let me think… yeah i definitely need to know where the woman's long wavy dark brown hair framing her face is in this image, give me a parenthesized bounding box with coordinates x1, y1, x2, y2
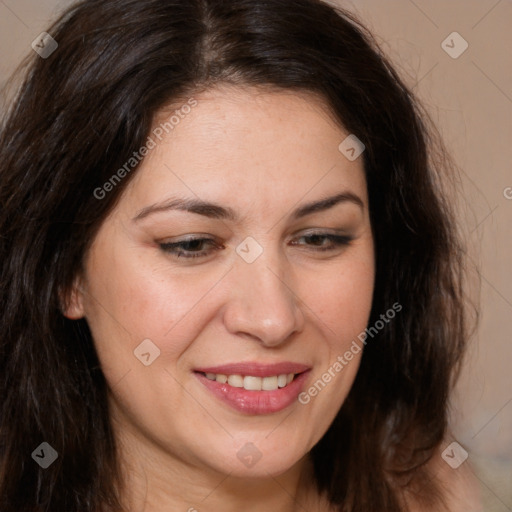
(0, 0, 467, 512)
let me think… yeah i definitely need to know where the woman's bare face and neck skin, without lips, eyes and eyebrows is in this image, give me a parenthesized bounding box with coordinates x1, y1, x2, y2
(66, 86, 375, 512)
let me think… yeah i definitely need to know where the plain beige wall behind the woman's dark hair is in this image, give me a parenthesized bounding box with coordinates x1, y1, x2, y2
(0, 0, 512, 512)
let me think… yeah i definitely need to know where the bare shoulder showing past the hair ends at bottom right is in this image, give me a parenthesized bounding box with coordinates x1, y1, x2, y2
(409, 445, 483, 512)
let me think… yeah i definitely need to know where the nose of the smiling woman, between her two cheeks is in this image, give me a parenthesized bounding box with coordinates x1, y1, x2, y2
(224, 249, 304, 347)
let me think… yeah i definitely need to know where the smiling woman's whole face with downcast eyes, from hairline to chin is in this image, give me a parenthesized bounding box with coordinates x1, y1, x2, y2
(67, 88, 374, 476)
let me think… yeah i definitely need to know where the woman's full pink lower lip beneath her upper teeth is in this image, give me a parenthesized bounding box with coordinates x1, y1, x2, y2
(194, 370, 309, 414)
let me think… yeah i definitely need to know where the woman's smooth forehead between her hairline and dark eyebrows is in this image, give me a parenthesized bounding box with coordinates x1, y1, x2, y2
(121, 87, 366, 218)
